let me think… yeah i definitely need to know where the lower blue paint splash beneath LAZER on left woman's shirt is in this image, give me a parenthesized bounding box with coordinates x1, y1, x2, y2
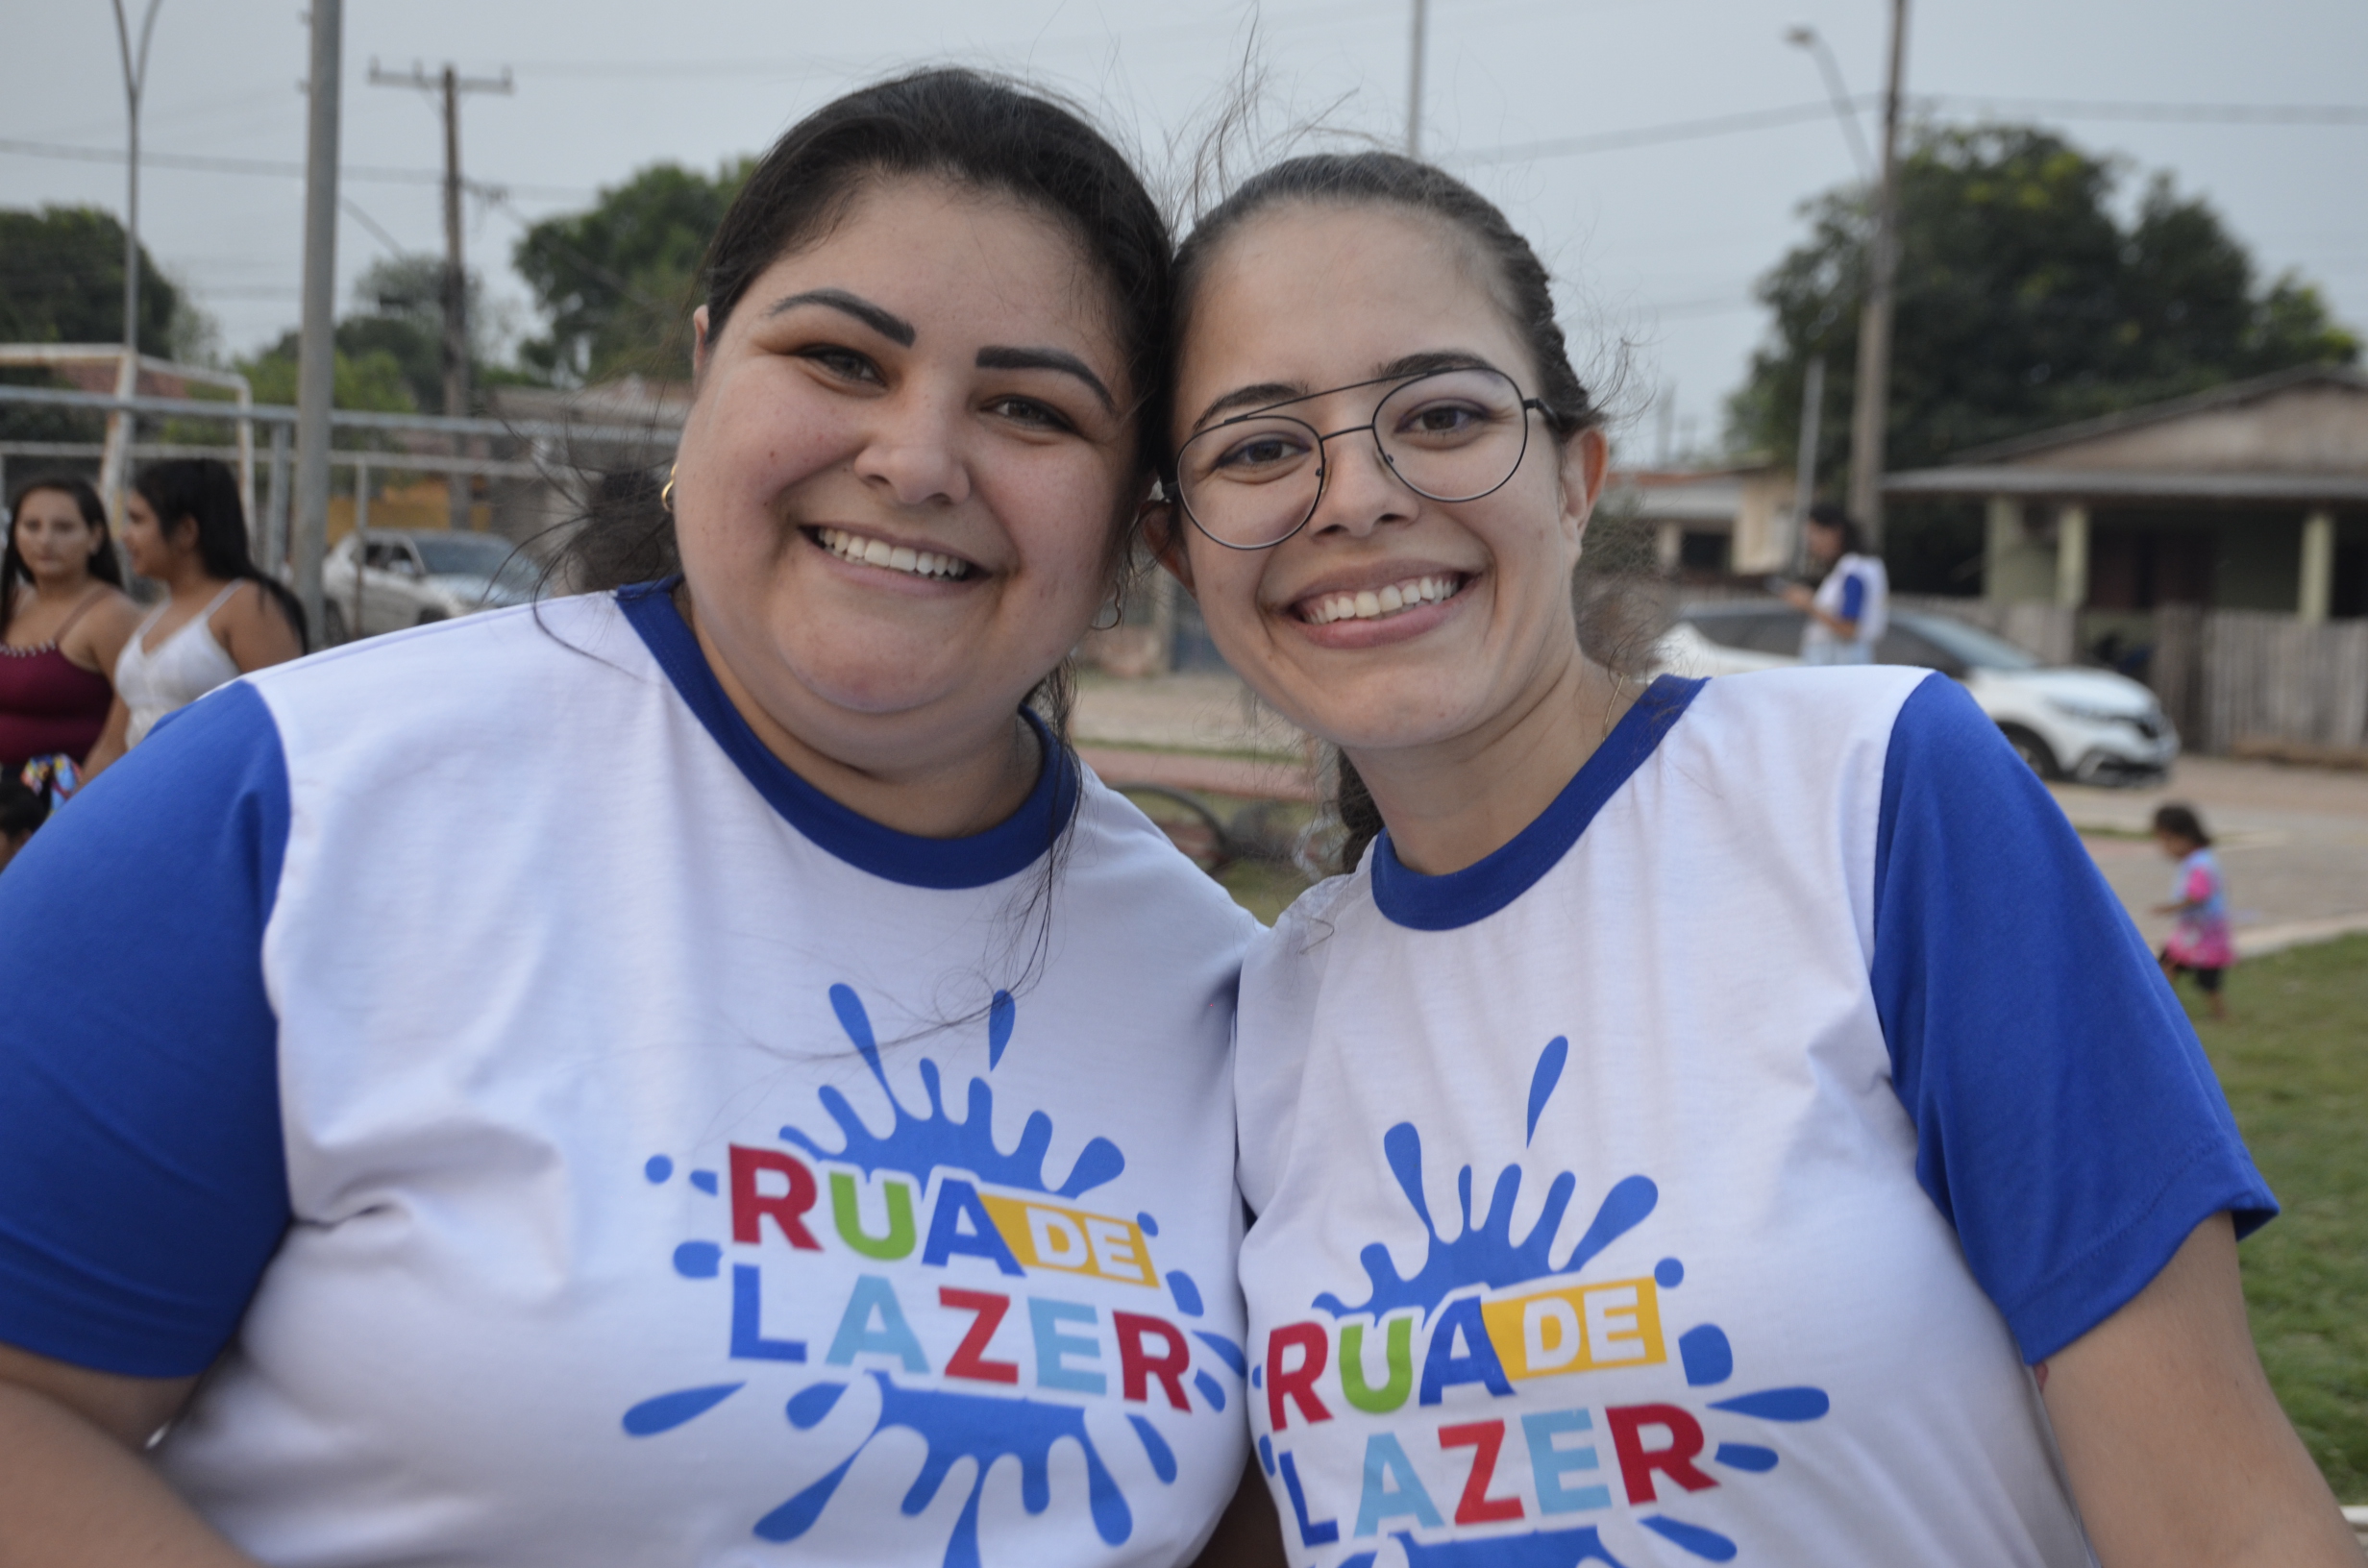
(755, 1371, 1131, 1568)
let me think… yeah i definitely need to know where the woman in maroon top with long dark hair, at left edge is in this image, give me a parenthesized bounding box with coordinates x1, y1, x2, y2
(0, 474, 139, 777)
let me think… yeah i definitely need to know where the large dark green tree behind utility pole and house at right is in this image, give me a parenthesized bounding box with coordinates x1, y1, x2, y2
(1729, 126, 2361, 587)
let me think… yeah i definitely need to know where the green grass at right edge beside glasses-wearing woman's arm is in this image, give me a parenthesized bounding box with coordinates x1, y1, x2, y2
(2181, 936, 2368, 1504)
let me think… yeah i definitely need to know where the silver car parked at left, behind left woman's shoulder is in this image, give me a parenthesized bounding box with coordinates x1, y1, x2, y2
(320, 528, 540, 645)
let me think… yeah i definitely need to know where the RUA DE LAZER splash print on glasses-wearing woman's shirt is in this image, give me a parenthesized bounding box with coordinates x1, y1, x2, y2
(1255, 1035, 1828, 1568)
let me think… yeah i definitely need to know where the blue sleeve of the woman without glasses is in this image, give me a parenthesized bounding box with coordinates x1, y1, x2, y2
(0, 684, 289, 1376)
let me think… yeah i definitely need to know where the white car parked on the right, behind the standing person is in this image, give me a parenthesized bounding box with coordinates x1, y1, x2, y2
(1655, 601, 2179, 784)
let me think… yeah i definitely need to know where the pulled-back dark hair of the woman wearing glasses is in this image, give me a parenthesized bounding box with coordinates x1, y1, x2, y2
(1160, 152, 1603, 871)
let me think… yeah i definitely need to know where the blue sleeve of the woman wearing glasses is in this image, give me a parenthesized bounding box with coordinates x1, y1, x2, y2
(1873, 675, 2278, 1362)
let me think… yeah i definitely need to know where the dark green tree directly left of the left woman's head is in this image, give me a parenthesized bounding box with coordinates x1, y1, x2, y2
(511, 159, 753, 381)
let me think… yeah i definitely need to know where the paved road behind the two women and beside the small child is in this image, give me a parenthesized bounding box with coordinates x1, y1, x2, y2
(1077, 673, 2368, 954)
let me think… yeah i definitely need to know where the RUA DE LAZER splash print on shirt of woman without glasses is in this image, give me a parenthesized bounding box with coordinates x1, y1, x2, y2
(621, 986, 1246, 1566)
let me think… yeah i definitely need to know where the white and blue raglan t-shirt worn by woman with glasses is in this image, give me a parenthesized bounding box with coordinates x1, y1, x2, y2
(1236, 671, 2276, 1568)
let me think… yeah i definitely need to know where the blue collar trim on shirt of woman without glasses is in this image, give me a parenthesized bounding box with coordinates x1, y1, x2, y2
(616, 578, 1080, 891)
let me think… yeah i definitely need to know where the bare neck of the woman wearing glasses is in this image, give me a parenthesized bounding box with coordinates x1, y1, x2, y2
(1349, 645, 1634, 876)
